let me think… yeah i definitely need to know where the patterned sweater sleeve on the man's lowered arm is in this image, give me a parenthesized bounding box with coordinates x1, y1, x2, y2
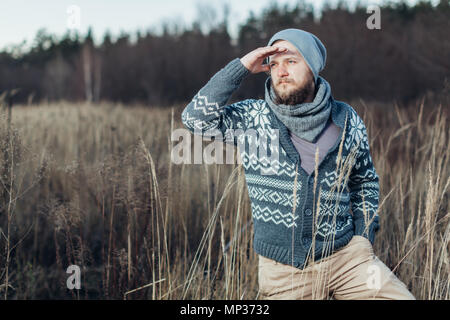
(348, 119, 379, 245)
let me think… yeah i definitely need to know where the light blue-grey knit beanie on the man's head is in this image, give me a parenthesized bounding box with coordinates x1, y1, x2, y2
(267, 29, 327, 83)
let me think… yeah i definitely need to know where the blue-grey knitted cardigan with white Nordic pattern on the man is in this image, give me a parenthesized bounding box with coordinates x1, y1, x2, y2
(182, 58, 379, 269)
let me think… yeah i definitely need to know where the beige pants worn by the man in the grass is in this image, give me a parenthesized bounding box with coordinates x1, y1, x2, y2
(258, 236, 415, 300)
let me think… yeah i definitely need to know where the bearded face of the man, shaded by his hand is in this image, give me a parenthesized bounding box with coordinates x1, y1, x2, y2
(269, 40, 315, 105)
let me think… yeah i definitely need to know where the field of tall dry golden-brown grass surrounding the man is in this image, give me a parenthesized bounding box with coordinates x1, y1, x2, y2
(0, 99, 450, 300)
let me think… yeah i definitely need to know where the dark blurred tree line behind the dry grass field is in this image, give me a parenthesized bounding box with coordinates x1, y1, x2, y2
(0, 0, 450, 106)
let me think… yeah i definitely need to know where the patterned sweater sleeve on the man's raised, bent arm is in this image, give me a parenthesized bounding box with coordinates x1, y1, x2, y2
(181, 58, 256, 145)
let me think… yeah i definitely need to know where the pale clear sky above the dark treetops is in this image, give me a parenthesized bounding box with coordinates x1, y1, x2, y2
(0, 0, 426, 49)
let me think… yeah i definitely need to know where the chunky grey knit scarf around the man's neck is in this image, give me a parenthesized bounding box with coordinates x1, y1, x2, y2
(265, 76, 333, 143)
